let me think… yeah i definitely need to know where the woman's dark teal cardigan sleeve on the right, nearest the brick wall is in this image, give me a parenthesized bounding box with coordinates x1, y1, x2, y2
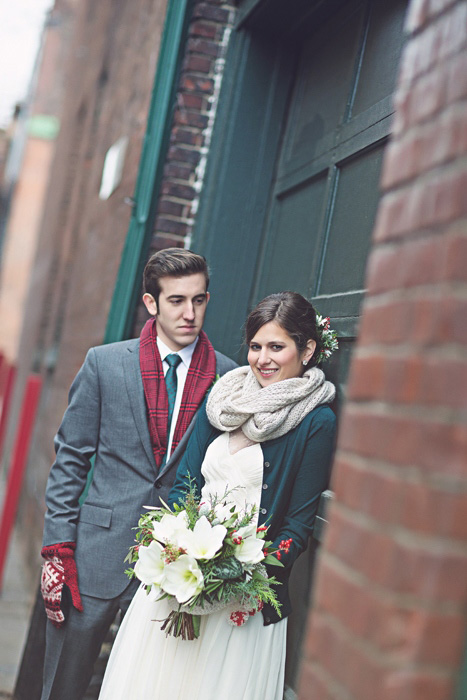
(271, 407, 336, 573)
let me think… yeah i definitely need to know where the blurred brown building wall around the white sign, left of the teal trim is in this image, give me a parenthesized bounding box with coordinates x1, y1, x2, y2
(8, 0, 167, 566)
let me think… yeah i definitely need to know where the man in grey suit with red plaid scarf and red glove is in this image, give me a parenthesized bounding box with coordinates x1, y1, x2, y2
(42, 248, 236, 700)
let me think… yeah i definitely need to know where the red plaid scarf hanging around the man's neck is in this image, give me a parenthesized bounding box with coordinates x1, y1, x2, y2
(139, 318, 216, 467)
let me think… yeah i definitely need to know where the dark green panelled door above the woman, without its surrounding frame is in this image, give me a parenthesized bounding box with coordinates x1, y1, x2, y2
(252, 0, 407, 391)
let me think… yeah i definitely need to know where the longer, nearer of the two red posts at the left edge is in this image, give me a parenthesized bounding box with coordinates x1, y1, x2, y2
(0, 375, 42, 590)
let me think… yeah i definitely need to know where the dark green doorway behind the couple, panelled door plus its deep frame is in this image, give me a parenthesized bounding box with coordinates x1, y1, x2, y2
(194, 0, 407, 395)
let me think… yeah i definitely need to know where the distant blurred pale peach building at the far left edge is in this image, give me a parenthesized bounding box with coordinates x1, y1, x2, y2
(0, 0, 76, 363)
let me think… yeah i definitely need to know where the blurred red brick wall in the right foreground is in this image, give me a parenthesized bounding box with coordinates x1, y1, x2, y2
(299, 0, 467, 700)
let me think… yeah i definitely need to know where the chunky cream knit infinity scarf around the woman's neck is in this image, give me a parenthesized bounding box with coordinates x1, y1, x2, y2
(206, 366, 336, 442)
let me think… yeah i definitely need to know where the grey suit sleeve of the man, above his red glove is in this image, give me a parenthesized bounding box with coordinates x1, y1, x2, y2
(43, 349, 101, 546)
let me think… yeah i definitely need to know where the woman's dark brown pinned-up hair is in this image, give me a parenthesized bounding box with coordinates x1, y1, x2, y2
(245, 292, 321, 367)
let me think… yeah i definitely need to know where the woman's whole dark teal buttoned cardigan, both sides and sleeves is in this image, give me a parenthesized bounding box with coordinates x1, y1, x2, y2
(168, 405, 336, 625)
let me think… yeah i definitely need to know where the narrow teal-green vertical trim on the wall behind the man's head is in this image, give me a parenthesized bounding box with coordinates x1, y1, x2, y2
(104, 0, 193, 343)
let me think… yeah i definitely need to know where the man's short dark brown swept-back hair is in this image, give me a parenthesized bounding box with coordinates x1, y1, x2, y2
(143, 248, 209, 303)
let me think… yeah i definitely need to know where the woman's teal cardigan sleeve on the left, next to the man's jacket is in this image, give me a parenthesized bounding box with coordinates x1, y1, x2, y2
(167, 399, 219, 507)
